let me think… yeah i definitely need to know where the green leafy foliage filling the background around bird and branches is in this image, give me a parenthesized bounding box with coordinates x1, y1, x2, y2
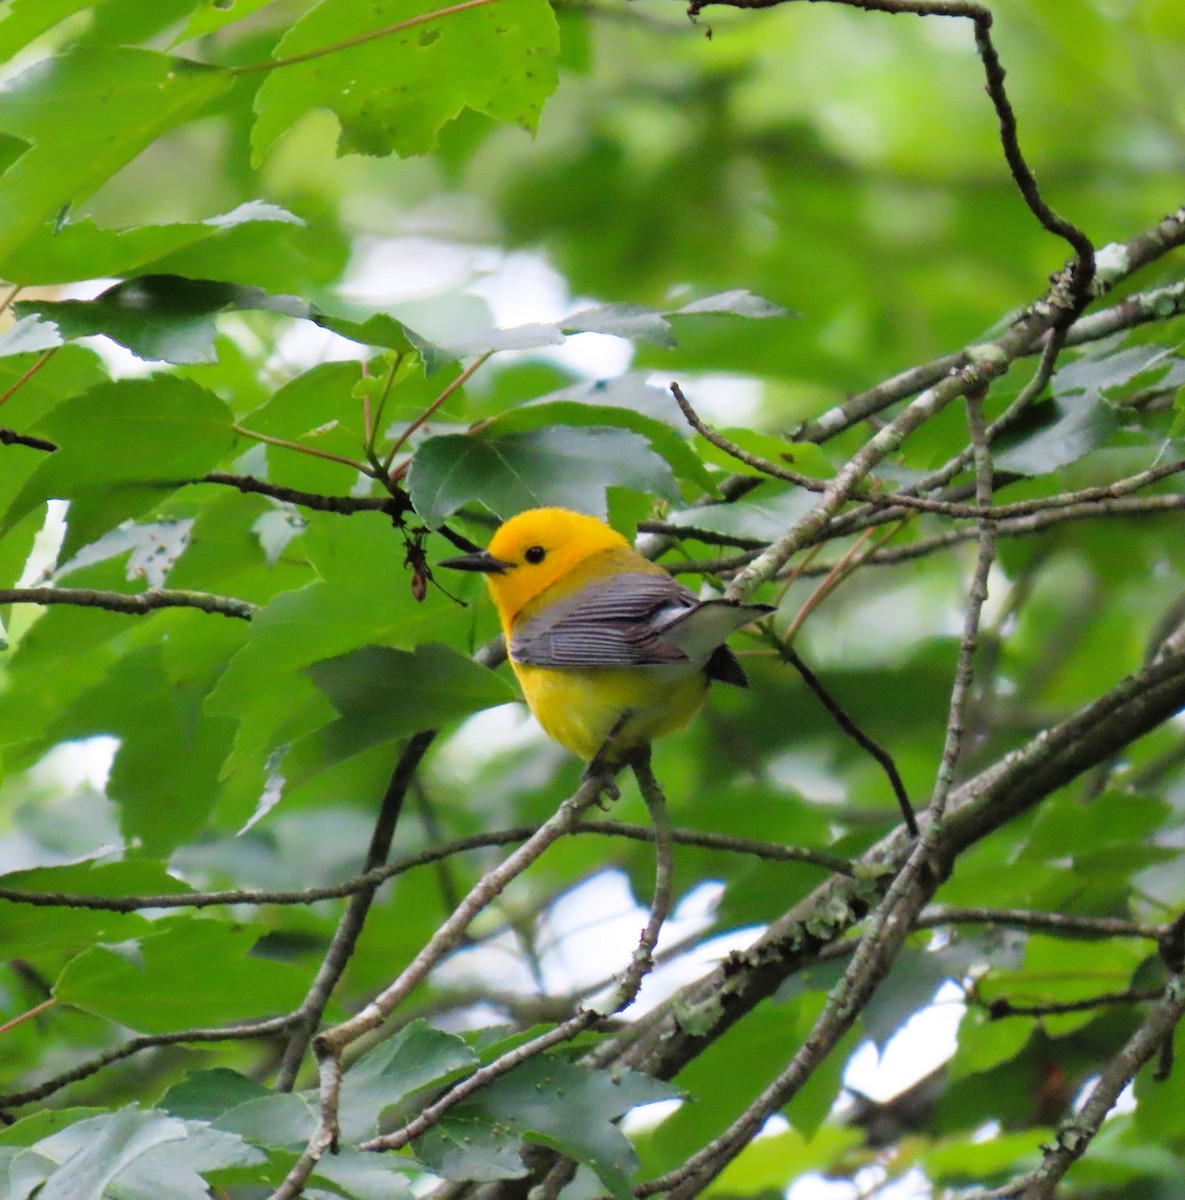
(0, 0, 1185, 1200)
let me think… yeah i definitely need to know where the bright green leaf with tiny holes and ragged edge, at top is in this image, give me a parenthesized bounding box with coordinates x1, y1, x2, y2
(252, 0, 559, 164)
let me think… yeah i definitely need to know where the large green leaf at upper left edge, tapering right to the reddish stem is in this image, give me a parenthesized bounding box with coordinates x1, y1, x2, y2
(0, 47, 233, 260)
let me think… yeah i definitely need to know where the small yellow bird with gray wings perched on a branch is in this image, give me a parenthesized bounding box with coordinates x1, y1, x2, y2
(440, 509, 774, 761)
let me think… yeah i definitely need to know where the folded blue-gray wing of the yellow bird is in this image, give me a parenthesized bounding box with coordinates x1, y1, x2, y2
(510, 571, 697, 667)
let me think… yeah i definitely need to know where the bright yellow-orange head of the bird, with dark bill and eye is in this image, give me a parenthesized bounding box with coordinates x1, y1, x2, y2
(439, 509, 630, 630)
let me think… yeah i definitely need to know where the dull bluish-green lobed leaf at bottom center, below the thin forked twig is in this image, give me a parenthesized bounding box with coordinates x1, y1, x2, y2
(415, 1057, 680, 1200)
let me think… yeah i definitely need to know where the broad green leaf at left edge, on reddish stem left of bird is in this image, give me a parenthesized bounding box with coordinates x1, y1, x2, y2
(0, 376, 235, 557)
